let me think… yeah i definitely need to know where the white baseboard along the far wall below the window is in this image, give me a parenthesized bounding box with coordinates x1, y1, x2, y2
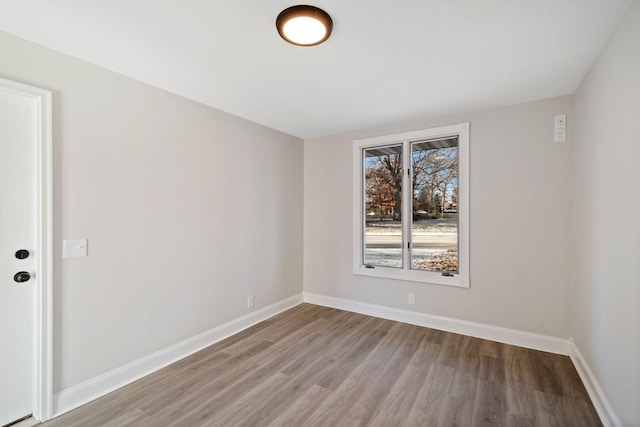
(304, 292, 569, 356)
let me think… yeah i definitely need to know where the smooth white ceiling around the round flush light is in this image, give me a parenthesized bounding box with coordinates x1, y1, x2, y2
(0, 0, 630, 138)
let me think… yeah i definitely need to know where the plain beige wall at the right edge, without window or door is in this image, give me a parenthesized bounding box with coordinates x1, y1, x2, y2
(571, 1, 640, 426)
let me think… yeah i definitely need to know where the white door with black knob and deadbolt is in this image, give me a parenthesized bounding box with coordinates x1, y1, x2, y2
(0, 86, 39, 426)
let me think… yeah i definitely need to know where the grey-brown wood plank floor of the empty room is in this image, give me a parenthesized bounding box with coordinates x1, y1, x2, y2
(43, 304, 602, 427)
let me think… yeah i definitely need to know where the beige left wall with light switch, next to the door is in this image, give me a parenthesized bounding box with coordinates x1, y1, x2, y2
(0, 33, 303, 392)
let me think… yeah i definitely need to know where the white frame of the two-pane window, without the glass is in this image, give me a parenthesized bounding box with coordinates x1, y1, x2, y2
(353, 122, 470, 288)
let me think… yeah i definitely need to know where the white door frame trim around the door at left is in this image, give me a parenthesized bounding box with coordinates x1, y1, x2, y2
(0, 78, 53, 421)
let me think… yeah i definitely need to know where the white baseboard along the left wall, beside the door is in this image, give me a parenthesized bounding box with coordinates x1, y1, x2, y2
(53, 294, 302, 418)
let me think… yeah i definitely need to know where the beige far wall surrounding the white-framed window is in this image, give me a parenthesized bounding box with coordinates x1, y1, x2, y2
(304, 96, 575, 338)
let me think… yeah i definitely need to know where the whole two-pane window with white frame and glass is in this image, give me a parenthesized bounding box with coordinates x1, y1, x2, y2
(353, 123, 469, 287)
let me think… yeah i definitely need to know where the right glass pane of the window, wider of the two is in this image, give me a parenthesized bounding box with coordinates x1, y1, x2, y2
(411, 137, 458, 272)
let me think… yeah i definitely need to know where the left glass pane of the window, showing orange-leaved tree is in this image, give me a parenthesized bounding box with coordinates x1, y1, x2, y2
(363, 145, 404, 268)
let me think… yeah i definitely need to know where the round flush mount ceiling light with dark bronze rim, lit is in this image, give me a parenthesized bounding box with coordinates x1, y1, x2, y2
(276, 5, 333, 46)
